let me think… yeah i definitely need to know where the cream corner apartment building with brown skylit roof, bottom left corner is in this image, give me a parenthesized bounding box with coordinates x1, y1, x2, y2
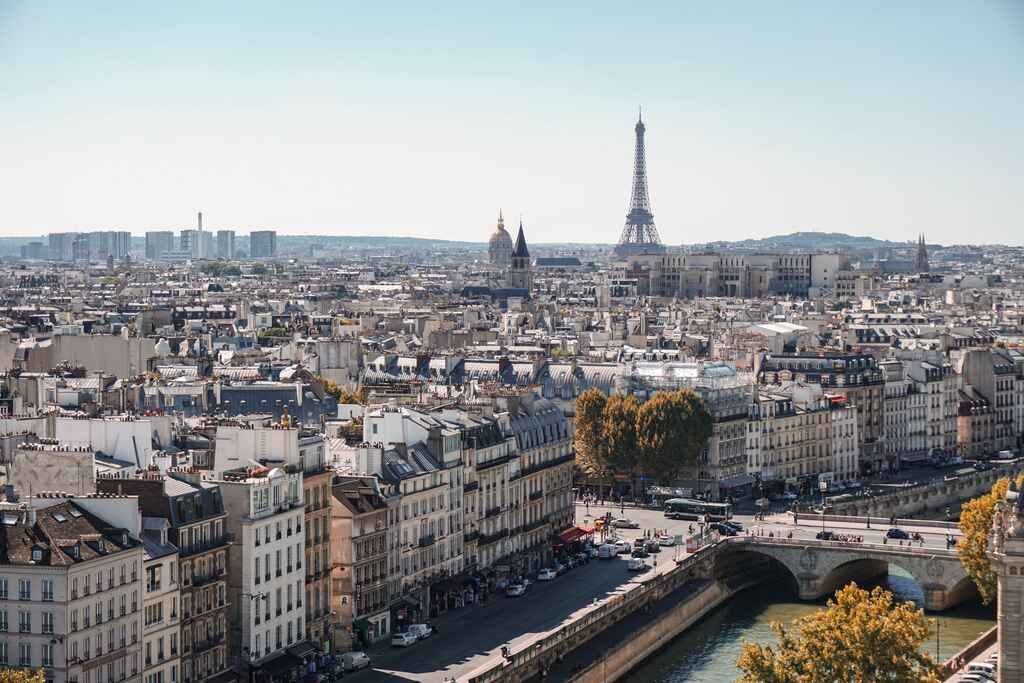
(0, 494, 143, 683)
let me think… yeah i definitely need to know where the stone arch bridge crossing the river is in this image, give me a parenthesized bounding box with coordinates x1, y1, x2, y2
(714, 537, 977, 611)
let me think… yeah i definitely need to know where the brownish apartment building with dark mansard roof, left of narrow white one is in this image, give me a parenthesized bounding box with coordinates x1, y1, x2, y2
(96, 467, 237, 683)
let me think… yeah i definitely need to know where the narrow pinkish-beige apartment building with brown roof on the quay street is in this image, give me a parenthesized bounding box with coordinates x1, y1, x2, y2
(331, 476, 392, 651)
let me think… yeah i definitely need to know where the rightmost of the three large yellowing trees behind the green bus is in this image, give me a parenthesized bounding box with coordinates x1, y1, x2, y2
(637, 389, 714, 483)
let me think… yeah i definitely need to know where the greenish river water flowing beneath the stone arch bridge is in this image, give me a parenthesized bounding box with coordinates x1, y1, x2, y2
(623, 568, 995, 683)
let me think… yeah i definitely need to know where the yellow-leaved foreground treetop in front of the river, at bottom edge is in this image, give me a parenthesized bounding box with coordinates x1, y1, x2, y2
(736, 584, 941, 683)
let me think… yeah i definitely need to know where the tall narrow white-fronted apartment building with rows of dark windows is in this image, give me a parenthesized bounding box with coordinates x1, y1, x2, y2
(217, 462, 315, 680)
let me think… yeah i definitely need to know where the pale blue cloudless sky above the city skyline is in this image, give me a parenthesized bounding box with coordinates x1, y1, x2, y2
(0, 0, 1024, 244)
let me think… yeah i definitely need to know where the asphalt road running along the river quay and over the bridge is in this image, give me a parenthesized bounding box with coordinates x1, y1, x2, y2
(352, 504, 962, 683)
